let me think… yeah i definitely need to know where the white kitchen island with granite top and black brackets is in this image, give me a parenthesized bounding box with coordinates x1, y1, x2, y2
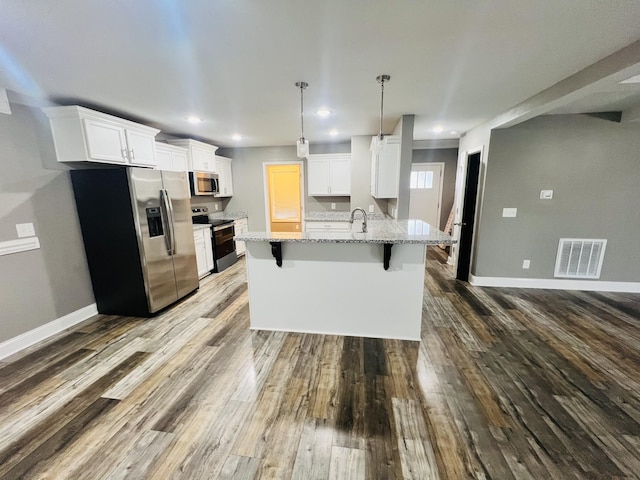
(236, 219, 455, 340)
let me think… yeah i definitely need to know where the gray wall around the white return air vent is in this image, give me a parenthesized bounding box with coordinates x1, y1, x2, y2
(473, 115, 640, 282)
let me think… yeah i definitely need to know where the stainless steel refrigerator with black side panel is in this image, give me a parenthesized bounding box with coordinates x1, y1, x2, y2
(71, 167, 199, 316)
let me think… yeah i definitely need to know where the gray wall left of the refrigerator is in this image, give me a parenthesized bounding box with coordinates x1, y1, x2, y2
(0, 104, 95, 342)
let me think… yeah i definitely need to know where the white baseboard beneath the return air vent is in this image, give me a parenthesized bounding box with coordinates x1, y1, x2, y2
(469, 275, 640, 293)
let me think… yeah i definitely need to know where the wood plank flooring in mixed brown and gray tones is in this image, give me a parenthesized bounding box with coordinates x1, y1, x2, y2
(0, 248, 640, 480)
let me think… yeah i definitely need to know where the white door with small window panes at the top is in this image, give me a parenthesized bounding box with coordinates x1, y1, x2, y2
(409, 163, 444, 228)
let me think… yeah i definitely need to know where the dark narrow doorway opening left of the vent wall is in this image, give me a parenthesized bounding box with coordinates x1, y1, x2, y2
(456, 152, 481, 282)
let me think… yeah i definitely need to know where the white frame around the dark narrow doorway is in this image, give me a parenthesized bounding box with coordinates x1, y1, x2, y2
(447, 145, 486, 276)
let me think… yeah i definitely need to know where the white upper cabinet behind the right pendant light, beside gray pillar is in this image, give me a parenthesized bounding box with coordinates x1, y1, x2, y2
(371, 135, 400, 198)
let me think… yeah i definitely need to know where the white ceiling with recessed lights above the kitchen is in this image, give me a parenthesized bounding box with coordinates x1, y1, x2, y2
(0, 0, 640, 146)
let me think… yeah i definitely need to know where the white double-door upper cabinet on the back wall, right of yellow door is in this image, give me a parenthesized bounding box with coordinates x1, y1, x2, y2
(307, 153, 351, 197)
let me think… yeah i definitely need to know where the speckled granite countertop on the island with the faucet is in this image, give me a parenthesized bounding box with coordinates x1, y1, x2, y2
(235, 219, 457, 245)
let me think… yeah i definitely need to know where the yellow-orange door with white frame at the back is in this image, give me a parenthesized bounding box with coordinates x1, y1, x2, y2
(267, 164, 302, 232)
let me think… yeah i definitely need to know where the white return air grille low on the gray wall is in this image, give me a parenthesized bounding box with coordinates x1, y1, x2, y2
(554, 238, 607, 278)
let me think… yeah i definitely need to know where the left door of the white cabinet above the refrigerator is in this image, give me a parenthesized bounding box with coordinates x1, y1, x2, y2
(84, 118, 128, 164)
